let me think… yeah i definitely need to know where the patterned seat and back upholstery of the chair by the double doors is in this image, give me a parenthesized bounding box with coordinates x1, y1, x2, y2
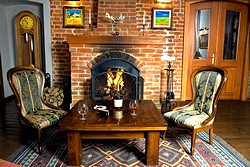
(164, 71, 222, 129)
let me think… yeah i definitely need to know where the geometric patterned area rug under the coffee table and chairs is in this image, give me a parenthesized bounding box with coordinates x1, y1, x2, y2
(9, 127, 250, 167)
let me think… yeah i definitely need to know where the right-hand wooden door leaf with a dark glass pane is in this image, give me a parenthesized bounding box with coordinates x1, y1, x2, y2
(216, 2, 248, 100)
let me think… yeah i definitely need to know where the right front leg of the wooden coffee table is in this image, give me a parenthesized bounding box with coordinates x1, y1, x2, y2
(146, 132, 160, 165)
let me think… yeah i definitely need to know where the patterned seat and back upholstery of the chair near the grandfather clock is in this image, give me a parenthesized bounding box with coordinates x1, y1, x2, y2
(13, 70, 67, 129)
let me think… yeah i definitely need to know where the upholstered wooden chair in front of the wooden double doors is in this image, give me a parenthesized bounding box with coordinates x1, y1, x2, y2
(164, 67, 227, 155)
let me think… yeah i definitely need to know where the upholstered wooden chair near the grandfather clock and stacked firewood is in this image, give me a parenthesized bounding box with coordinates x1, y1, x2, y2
(7, 66, 67, 154)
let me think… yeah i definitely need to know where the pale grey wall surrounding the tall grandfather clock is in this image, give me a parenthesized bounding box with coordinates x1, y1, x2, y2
(0, 0, 52, 97)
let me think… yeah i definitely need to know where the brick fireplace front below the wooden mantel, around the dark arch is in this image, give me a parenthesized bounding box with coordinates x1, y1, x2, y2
(70, 41, 163, 105)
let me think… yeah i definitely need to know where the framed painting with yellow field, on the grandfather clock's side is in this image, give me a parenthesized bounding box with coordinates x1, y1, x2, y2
(63, 6, 85, 28)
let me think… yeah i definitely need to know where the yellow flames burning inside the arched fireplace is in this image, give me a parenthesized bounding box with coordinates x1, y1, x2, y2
(107, 69, 124, 92)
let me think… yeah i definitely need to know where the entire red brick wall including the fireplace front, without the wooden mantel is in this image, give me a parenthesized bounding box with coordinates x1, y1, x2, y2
(50, 0, 184, 107)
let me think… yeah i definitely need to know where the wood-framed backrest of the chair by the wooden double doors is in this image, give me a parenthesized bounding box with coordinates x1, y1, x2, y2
(192, 67, 226, 115)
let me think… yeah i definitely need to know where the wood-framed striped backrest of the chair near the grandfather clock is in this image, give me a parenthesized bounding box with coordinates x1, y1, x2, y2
(7, 66, 45, 116)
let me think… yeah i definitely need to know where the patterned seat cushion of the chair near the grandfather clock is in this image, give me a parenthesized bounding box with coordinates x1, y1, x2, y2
(25, 109, 67, 129)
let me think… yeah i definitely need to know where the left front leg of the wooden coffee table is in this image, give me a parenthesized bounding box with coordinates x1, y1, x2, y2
(67, 132, 82, 166)
